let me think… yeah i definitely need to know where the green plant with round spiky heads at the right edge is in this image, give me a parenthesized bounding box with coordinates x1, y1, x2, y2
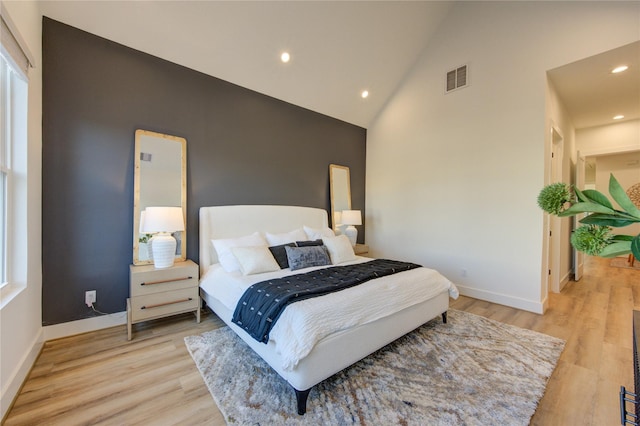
(538, 174, 640, 260)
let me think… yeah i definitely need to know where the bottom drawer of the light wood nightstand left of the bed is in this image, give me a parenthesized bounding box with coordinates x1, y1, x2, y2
(131, 288, 200, 323)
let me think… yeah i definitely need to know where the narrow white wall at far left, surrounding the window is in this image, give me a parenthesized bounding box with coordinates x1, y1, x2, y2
(0, 2, 42, 417)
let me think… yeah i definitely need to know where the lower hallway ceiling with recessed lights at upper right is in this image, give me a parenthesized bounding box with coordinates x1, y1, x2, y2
(548, 41, 640, 129)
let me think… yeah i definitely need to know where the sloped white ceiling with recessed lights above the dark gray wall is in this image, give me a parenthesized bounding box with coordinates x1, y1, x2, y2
(41, 1, 454, 127)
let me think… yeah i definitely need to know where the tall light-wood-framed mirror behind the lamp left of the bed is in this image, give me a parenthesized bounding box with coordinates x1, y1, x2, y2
(133, 130, 187, 265)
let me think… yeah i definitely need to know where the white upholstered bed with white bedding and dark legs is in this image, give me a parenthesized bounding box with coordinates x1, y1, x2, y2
(199, 205, 457, 415)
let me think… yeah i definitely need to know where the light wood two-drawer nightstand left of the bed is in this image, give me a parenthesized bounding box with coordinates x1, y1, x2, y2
(127, 260, 200, 340)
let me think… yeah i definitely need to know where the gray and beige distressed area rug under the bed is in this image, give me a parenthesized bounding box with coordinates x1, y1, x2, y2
(185, 310, 564, 426)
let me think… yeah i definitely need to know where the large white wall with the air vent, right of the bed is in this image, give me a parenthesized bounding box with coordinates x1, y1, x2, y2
(366, 2, 640, 312)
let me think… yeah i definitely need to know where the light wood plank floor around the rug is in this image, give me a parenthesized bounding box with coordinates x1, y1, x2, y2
(5, 258, 640, 426)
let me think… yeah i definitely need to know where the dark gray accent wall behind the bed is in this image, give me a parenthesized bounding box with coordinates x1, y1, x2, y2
(42, 17, 366, 325)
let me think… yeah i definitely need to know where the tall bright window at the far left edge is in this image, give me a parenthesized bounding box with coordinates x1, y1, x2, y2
(0, 13, 29, 296)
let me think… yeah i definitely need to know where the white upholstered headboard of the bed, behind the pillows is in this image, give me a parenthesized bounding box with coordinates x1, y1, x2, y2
(200, 205, 329, 277)
